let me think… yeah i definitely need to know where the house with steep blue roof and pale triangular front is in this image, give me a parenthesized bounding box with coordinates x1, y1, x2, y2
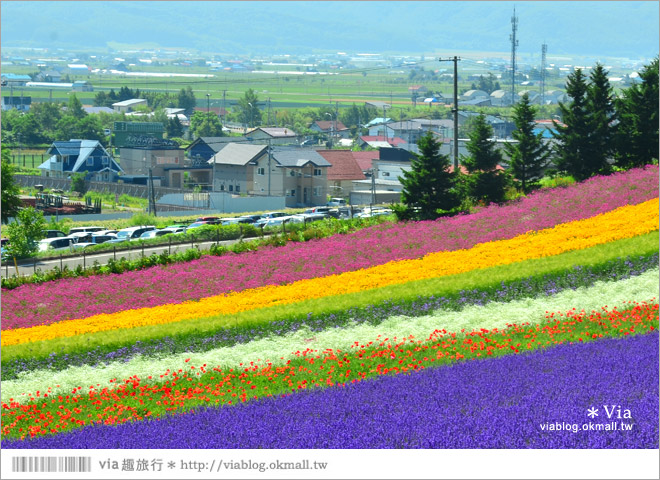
(38, 140, 124, 182)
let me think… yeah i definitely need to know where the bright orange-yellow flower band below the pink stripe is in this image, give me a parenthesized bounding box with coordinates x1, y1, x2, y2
(2, 199, 658, 346)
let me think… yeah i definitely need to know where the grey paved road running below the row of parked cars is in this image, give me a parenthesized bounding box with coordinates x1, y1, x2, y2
(0, 235, 252, 278)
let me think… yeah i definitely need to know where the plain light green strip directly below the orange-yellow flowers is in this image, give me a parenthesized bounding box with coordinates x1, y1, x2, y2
(2, 232, 660, 361)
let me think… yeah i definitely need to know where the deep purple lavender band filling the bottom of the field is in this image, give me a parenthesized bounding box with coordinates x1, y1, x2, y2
(7, 332, 658, 449)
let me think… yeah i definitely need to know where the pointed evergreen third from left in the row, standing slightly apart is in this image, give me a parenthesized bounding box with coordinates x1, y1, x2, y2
(504, 93, 550, 195)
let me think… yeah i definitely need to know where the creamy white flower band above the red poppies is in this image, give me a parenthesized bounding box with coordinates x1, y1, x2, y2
(2, 269, 660, 403)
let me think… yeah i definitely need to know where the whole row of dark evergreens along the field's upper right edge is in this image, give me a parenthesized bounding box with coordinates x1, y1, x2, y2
(397, 58, 660, 220)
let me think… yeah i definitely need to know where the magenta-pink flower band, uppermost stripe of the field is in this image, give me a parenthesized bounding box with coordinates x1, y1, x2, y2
(1, 166, 659, 330)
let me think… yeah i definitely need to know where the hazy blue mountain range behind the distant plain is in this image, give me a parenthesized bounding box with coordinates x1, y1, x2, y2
(0, 1, 660, 59)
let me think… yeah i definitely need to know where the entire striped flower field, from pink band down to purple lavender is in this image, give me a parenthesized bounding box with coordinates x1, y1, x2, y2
(2, 166, 660, 449)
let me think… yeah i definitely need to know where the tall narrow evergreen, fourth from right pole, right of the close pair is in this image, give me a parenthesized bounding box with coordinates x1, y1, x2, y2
(586, 63, 614, 175)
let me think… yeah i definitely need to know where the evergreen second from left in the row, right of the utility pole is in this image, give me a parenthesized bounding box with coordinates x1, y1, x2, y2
(461, 114, 508, 204)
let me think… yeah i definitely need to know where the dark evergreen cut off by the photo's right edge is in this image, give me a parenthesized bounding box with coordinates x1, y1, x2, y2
(615, 58, 660, 168)
